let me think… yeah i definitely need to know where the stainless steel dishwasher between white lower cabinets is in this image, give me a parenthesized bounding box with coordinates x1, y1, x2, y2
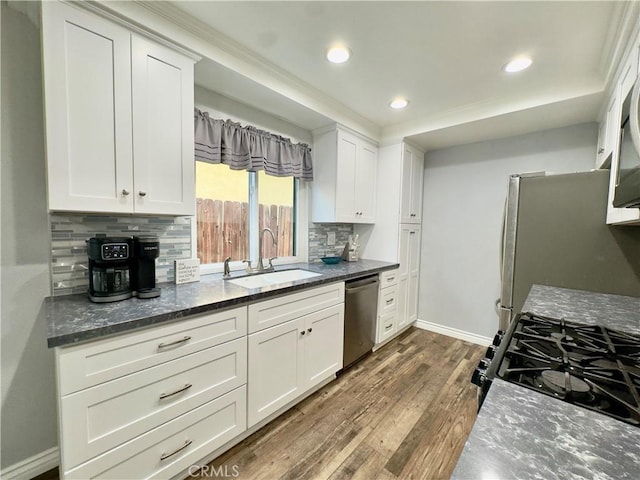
(343, 275, 379, 368)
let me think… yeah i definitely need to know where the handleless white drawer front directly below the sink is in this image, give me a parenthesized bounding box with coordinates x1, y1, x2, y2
(249, 282, 344, 333)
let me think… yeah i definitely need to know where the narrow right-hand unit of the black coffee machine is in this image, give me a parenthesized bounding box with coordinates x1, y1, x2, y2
(131, 236, 160, 298)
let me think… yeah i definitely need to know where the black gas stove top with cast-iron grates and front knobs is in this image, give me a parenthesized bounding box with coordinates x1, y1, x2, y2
(474, 313, 640, 426)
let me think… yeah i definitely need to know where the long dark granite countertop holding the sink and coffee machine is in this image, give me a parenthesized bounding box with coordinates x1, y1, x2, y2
(44, 260, 398, 347)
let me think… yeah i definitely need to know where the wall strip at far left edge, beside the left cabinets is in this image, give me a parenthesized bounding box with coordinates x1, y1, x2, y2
(0, 1, 57, 473)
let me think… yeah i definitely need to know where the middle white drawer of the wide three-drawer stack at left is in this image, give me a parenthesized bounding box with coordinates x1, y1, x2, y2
(60, 338, 247, 467)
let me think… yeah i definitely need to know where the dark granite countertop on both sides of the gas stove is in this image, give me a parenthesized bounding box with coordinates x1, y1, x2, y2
(451, 285, 640, 480)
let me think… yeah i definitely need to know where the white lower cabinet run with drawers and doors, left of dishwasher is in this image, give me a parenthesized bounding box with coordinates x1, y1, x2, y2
(56, 282, 344, 479)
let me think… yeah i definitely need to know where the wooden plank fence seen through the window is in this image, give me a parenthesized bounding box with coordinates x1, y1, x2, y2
(196, 198, 294, 264)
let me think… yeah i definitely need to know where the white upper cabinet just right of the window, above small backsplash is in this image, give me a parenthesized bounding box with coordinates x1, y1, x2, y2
(312, 127, 378, 223)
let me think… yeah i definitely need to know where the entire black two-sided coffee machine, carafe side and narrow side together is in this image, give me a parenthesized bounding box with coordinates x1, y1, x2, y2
(87, 236, 160, 303)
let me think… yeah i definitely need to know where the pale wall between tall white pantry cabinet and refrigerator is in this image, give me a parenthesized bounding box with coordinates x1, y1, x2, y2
(418, 123, 598, 337)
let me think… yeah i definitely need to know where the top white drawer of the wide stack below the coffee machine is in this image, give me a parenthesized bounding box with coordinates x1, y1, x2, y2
(56, 307, 247, 395)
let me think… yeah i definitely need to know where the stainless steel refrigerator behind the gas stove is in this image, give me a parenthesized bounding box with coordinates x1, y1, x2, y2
(497, 170, 640, 331)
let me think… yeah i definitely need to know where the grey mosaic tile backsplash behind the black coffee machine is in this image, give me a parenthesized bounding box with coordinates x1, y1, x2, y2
(50, 214, 191, 296)
